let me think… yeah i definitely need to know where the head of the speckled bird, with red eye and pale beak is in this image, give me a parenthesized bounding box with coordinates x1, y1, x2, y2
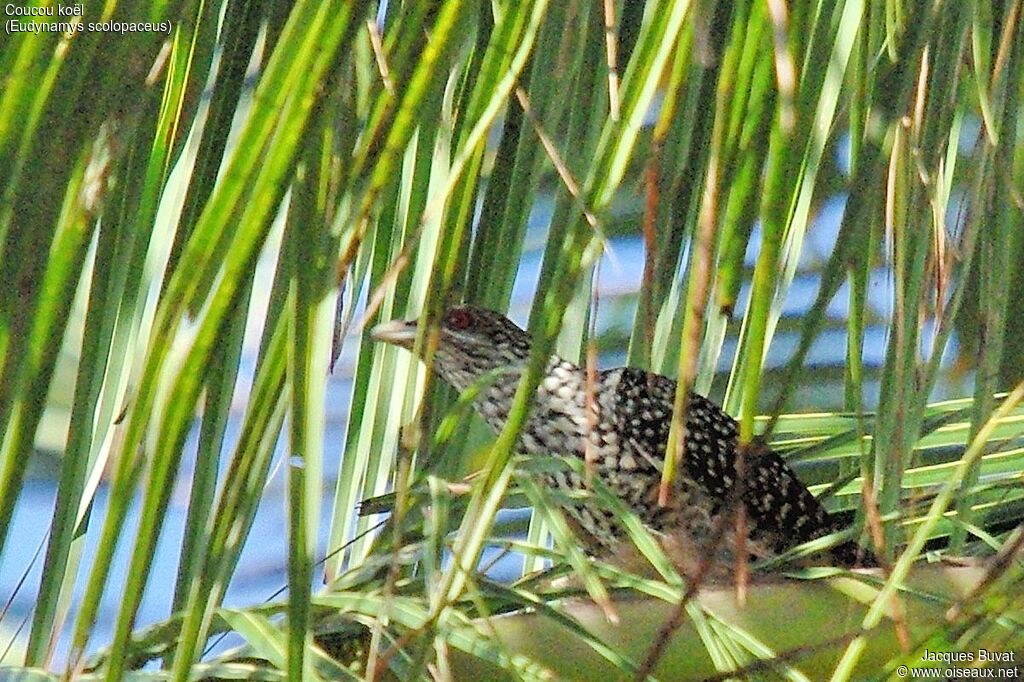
(371, 305, 529, 391)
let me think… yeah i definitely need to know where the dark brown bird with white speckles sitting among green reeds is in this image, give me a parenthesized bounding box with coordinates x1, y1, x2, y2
(371, 305, 870, 578)
